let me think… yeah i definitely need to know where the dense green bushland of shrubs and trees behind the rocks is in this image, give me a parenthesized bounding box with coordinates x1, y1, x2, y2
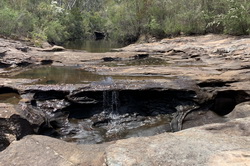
(0, 0, 250, 45)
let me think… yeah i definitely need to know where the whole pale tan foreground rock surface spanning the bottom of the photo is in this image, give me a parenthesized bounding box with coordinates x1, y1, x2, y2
(0, 118, 250, 166)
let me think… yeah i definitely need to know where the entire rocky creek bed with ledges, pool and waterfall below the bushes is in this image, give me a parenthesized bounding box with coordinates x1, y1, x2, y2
(0, 35, 250, 166)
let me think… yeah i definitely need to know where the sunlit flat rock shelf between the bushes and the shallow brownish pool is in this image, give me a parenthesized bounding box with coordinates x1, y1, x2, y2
(0, 35, 250, 92)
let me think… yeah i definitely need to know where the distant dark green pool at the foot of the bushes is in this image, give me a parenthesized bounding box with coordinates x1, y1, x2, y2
(64, 40, 124, 52)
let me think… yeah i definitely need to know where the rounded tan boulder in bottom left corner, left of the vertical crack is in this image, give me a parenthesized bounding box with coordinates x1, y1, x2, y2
(0, 135, 109, 166)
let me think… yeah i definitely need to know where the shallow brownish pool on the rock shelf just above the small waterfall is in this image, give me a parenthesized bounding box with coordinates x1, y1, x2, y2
(13, 66, 169, 85)
